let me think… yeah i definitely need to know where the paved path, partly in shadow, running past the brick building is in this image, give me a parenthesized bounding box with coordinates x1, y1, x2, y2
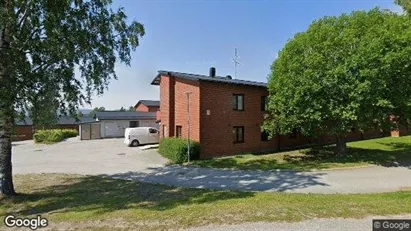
(110, 165, 411, 194)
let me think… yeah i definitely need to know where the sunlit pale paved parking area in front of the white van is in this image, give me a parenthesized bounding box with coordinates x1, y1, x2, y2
(12, 138, 167, 174)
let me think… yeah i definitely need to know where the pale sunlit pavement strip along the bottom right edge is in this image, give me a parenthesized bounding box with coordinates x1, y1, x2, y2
(189, 214, 411, 231)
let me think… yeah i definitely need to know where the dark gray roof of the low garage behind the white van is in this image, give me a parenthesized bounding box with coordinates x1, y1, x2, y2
(96, 111, 156, 120)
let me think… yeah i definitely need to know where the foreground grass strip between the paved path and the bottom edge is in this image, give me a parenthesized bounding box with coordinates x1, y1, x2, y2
(0, 174, 411, 230)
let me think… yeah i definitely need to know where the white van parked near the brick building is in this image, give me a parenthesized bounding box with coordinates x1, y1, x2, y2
(124, 127, 160, 147)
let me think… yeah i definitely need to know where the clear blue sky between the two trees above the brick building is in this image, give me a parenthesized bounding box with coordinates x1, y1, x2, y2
(88, 0, 400, 110)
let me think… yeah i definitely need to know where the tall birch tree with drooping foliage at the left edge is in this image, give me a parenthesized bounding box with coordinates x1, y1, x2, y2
(0, 0, 144, 196)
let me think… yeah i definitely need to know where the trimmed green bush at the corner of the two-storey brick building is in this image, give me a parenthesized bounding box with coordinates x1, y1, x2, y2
(158, 138, 200, 164)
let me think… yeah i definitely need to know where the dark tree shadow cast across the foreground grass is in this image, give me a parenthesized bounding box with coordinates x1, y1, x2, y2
(0, 176, 254, 215)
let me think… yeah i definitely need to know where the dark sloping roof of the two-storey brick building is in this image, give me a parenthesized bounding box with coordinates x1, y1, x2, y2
(151, 71, 267, 88)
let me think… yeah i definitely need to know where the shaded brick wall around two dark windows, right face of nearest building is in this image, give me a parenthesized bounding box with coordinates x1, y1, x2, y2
(200, 81, 277, 158)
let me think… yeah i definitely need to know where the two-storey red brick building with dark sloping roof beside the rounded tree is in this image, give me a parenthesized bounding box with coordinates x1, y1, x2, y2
(152, 68, 381, 158)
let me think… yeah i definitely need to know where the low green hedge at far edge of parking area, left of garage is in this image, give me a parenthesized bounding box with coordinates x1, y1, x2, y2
(33, 129, 78, 143)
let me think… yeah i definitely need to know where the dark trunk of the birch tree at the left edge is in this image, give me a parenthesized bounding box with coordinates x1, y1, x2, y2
(0, 1, 16, 197)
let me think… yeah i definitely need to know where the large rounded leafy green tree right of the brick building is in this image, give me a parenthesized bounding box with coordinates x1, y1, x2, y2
(264, 8, 411, 155)
